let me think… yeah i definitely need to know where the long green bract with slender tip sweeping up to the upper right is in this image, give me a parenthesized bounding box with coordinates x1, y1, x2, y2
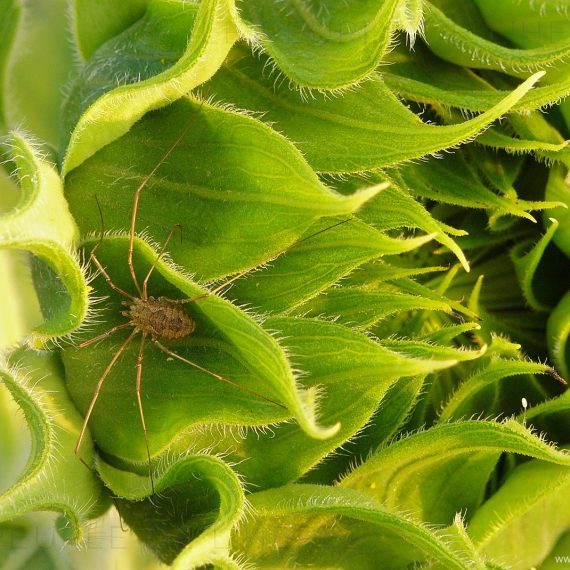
(205, 46, 543, 173)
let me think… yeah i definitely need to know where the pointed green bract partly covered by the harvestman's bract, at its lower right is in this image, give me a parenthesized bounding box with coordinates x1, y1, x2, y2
(181, 317, 466, 488)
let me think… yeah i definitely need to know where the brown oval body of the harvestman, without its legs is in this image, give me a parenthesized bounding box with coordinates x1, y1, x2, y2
(126, 297, 196, 340)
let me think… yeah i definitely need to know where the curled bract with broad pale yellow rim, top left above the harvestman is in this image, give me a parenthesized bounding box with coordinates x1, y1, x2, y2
(63, 0, 237, 173)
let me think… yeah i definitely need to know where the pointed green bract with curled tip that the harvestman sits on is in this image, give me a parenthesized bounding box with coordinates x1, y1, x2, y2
(63, 237, 338, 469)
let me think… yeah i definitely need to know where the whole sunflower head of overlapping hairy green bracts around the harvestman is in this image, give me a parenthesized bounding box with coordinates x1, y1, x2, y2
(0, 0, 570, 568)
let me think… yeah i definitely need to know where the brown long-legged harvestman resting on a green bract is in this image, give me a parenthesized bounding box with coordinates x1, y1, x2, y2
(74, 122, 285, 491)
